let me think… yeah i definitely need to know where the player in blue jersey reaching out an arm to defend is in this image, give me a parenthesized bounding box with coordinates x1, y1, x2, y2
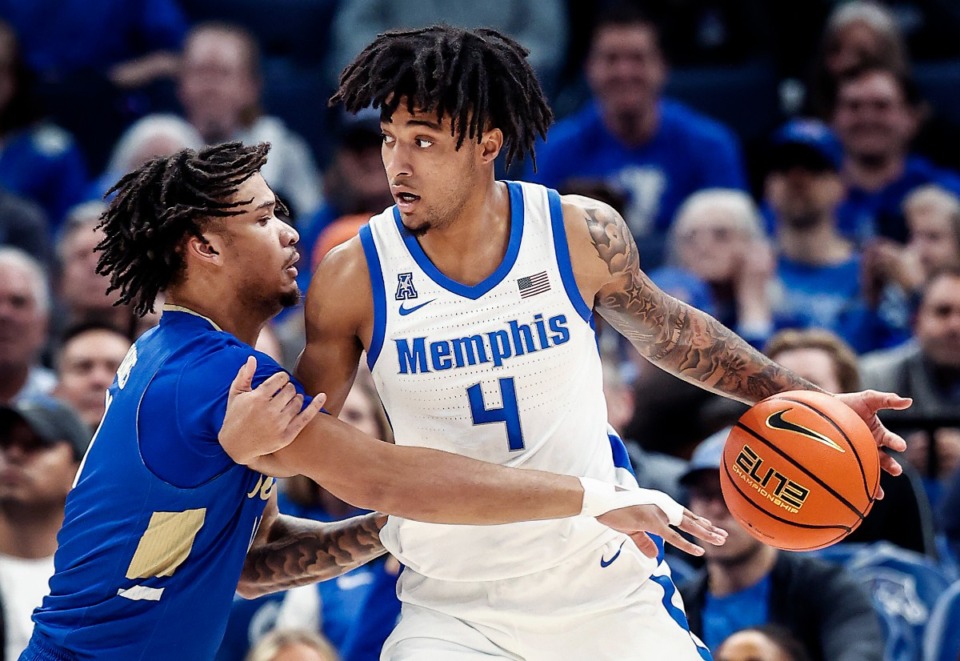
(21, 143, 723, 661)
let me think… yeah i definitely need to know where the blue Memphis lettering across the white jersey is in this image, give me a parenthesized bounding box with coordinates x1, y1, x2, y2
(394, 314, 570, 374)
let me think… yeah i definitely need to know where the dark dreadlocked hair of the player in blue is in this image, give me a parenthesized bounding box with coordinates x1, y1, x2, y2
(95, 142, 282, 316)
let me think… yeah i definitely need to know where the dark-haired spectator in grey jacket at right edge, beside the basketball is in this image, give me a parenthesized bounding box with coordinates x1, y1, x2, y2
(861, 267, 960, 498)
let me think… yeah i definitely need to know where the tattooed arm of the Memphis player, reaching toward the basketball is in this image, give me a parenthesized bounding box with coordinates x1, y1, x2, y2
(584, 205, 816, 403)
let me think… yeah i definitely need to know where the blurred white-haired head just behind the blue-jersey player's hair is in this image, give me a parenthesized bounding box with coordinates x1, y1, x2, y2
(86, 114, 203, 200)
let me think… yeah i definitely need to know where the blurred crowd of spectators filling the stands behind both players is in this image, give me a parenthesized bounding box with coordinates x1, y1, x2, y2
(0, 0, 960, 661)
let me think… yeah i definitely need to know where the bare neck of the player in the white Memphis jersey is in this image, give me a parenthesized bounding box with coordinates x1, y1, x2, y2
(419, 177, 515, 285)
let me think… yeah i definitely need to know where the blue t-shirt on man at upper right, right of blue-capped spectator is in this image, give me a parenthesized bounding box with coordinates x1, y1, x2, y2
(837, 156, 960, 244)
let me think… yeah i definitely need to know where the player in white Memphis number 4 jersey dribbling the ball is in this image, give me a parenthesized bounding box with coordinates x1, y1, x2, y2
(296, 26, 909, 661)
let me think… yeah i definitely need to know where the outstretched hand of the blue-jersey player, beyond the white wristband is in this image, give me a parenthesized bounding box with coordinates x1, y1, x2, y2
(597, 505, 727, 558)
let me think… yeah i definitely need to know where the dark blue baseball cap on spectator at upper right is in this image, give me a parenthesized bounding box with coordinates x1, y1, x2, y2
(768, 119, 843, 172)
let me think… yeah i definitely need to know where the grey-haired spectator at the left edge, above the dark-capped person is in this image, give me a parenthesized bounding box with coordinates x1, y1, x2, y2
(0, 247, 56, 404)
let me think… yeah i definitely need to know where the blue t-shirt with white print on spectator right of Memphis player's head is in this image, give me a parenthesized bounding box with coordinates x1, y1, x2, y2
(524, 99, 747, 236)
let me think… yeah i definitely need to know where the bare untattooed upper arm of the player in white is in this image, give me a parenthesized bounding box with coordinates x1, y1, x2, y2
(294, 238, 373, 414)
